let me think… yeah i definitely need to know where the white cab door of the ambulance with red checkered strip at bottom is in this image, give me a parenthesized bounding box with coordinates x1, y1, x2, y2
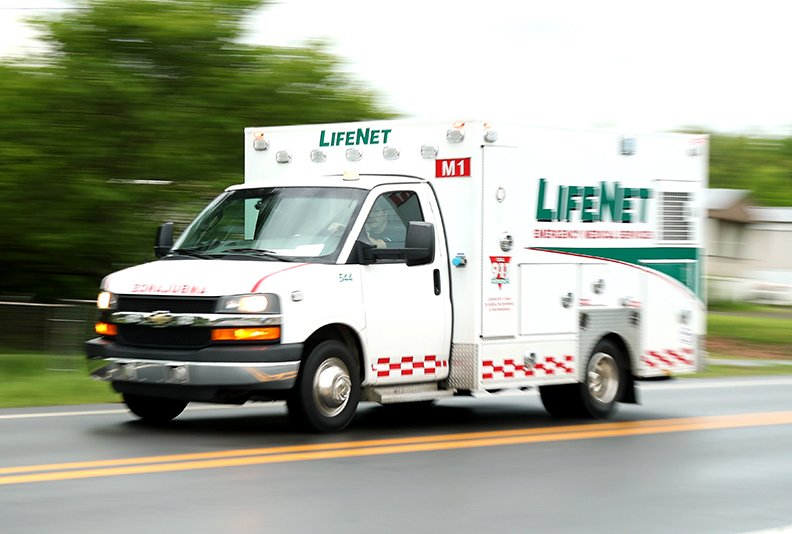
(357, 184, 451, 384)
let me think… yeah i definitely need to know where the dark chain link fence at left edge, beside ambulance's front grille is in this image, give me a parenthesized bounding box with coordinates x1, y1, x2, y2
(0, 300, 96, 354)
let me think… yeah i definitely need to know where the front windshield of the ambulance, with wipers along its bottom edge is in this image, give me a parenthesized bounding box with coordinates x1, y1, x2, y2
(172, 187, 366, 262)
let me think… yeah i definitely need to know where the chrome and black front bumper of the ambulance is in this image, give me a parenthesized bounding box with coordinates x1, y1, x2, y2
(85, 338, 303, 391)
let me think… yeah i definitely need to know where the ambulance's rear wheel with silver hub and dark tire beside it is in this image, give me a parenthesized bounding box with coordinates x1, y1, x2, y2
(539, 339, 627, 419)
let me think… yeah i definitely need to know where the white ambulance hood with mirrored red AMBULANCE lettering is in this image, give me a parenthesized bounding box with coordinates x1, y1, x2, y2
(102, 259, 309, 297)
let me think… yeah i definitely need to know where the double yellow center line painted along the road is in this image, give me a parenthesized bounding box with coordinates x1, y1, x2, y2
(0, 411, 792, 485)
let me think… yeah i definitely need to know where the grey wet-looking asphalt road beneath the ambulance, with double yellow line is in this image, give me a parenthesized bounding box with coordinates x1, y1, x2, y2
(0, 378, 792, 534)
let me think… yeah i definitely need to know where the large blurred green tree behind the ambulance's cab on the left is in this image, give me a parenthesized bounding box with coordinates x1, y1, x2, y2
(0, 0, 390, 300)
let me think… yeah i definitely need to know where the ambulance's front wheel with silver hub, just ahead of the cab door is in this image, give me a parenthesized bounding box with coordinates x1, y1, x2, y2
(286, 340, 360, 432)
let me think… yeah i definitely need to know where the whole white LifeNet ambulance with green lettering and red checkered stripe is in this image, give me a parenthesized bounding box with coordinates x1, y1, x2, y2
(86, 121, 708, 431)
